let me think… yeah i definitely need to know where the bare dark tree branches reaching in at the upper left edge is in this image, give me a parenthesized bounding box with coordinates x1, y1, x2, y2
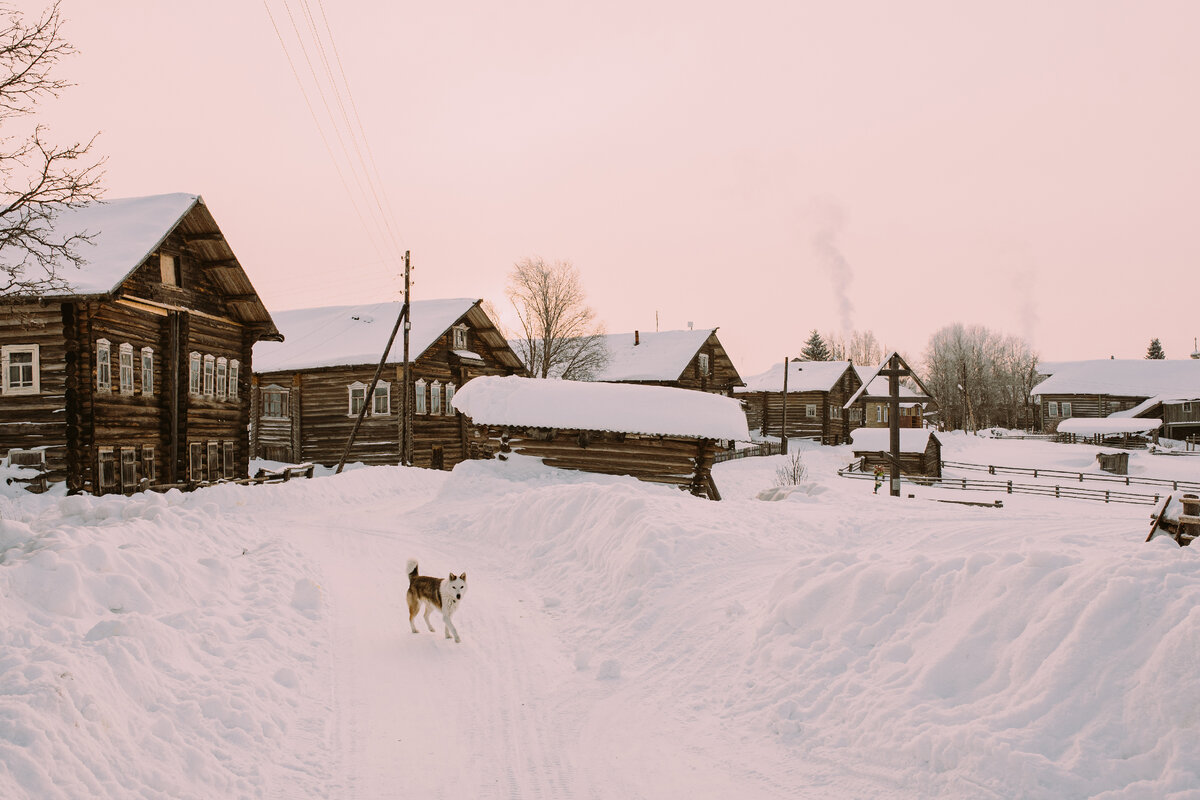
(0, 1, 102, 302)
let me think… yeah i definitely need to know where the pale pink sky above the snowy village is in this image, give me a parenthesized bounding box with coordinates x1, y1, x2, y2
(16, 0, 1200, 375)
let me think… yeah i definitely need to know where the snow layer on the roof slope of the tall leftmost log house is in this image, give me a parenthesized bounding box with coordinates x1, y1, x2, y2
(18, 193, 203, 297)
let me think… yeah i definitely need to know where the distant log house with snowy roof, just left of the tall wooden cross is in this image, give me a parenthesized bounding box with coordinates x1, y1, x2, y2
(734, 360, 863, 445)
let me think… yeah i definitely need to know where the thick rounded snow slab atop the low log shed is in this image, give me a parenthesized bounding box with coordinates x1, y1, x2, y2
(454, 375, 750, 441)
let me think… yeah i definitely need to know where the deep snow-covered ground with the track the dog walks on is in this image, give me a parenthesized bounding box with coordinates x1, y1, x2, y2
(0, 434, 1200, 800)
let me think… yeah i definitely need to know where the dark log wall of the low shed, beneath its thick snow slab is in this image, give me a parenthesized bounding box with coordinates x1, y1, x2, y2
(479, 426, 716, 499)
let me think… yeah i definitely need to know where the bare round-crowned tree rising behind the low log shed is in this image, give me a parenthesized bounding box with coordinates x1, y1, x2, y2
(508, 258, 608, 380)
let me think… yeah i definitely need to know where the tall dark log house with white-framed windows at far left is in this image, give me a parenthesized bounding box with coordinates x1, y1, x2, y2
(0, 194, 280, 494)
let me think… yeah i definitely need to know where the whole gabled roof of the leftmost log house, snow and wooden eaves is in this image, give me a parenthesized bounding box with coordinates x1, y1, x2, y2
(19, 192, 278, 337)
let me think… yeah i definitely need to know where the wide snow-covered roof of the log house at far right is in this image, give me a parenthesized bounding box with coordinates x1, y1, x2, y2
(1031, 359, 1200, 397)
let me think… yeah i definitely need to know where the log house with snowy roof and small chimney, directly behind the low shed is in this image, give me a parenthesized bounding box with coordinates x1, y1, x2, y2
(594, 327, 745, 397)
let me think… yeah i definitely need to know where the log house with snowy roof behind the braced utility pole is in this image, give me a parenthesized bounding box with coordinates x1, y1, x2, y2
(251, 299, 524, 469)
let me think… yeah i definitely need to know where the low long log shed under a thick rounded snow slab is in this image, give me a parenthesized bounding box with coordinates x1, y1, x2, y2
(454, 378, 750, 500)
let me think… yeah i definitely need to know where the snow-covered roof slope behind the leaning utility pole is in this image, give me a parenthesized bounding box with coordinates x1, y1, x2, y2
(254, 297, 479, 372)
